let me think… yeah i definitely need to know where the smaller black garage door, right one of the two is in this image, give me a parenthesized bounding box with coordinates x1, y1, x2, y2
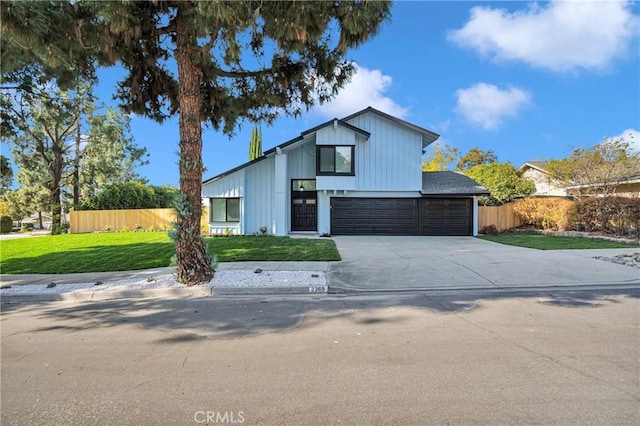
(420, 198, 473, 236)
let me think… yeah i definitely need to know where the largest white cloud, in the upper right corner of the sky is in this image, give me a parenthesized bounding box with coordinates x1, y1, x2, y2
(448, 1, 638, 71)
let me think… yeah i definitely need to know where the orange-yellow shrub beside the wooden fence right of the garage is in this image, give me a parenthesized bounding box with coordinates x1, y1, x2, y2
(513, 197, 575, 231)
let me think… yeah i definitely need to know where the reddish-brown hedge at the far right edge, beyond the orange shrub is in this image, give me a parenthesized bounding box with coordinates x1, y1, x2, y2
(573, 197, 640, 237)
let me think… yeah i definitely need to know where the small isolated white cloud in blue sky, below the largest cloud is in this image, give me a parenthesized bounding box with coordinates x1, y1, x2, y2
(456, 83, 531, 130)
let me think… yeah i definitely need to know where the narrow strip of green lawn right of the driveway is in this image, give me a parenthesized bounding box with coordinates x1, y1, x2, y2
(479, 232, 638, 250)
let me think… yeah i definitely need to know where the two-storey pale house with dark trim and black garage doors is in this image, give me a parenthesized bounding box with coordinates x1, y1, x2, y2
(202, 107, 488, 235)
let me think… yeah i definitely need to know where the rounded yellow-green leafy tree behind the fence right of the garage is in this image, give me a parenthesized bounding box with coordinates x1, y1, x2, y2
(465, 163, 536, 205)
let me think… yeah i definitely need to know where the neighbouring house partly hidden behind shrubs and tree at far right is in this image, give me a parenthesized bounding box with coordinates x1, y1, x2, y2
(520, 161, 640, 197)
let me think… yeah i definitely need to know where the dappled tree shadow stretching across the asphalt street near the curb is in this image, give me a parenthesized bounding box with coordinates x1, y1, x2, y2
(2, 289, 640, 344)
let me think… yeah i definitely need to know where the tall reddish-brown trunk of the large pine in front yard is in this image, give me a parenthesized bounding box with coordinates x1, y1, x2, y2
(175, 3, 213, 285)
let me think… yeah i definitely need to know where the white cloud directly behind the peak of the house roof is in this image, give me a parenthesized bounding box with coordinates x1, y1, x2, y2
(317, 65, 409, 118)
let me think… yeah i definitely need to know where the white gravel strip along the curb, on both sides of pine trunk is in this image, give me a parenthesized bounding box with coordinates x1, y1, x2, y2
(0, 270, 327, 295)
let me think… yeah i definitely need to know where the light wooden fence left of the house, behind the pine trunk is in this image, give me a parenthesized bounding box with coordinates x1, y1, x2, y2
(69, 208, 209, 234)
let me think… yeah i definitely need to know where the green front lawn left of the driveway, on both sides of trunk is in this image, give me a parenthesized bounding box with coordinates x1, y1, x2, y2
(0, 232, 340, 274)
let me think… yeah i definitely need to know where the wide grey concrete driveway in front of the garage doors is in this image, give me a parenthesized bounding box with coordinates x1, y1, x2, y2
(328, 236, 640, 292)
